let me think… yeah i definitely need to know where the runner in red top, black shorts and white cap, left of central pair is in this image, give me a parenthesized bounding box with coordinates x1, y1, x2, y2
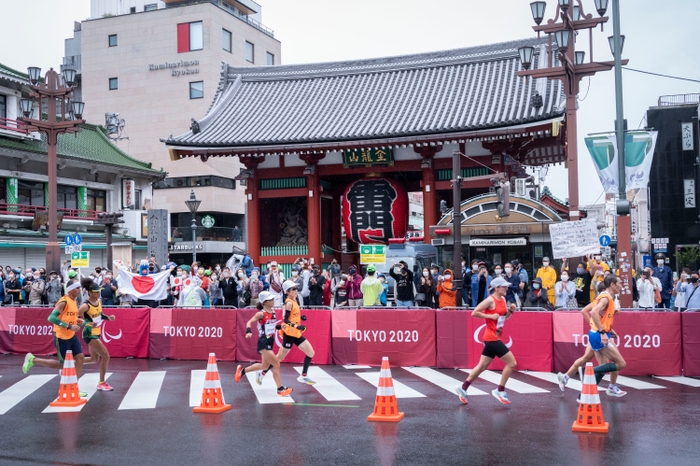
(235, 291, 292, 396)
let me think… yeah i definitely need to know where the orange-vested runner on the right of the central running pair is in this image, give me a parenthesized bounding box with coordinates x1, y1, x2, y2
(277, 280, 316, 385)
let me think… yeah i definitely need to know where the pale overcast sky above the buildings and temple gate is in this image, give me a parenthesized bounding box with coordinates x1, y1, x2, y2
(0, 0, 700, 208)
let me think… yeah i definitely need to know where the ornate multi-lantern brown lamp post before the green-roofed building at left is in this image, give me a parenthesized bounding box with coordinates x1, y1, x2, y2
(19, 66, 85, 270)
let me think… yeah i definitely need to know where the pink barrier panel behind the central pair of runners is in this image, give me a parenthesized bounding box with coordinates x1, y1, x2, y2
(236, 308, 331, 364)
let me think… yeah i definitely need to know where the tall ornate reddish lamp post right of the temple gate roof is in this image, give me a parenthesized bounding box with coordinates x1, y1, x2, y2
(517, 0, 627, 220)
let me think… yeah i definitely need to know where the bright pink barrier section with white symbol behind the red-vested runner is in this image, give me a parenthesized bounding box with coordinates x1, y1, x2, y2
(467, 311, 552, 372)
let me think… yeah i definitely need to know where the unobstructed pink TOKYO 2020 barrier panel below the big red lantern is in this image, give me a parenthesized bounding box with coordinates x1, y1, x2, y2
(332, 308, 435, 366)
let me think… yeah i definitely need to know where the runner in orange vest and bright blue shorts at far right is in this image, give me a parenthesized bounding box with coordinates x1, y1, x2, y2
(557, 274, 627, 397)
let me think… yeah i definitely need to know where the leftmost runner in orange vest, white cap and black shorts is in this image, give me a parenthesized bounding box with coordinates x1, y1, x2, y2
(22, 279, 87, 396)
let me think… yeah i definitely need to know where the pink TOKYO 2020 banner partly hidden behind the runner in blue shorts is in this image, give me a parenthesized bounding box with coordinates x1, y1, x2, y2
(553, 311, 680, 376)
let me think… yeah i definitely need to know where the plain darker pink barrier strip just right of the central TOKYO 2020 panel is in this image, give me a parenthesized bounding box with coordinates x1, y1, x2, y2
(435, 309, 472, 368)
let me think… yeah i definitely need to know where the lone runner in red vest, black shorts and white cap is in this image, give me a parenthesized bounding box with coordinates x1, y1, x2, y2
(455, 277, 517, 405)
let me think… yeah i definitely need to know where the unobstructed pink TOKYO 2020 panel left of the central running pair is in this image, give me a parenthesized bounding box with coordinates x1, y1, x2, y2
(148, 308, 237, 361)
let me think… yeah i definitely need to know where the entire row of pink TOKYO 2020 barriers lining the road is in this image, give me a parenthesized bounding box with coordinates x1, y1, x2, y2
(0, 307, 700, 376)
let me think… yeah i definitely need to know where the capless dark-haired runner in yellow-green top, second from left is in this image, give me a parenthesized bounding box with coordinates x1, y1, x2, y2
(78, 278, 114, 392)
